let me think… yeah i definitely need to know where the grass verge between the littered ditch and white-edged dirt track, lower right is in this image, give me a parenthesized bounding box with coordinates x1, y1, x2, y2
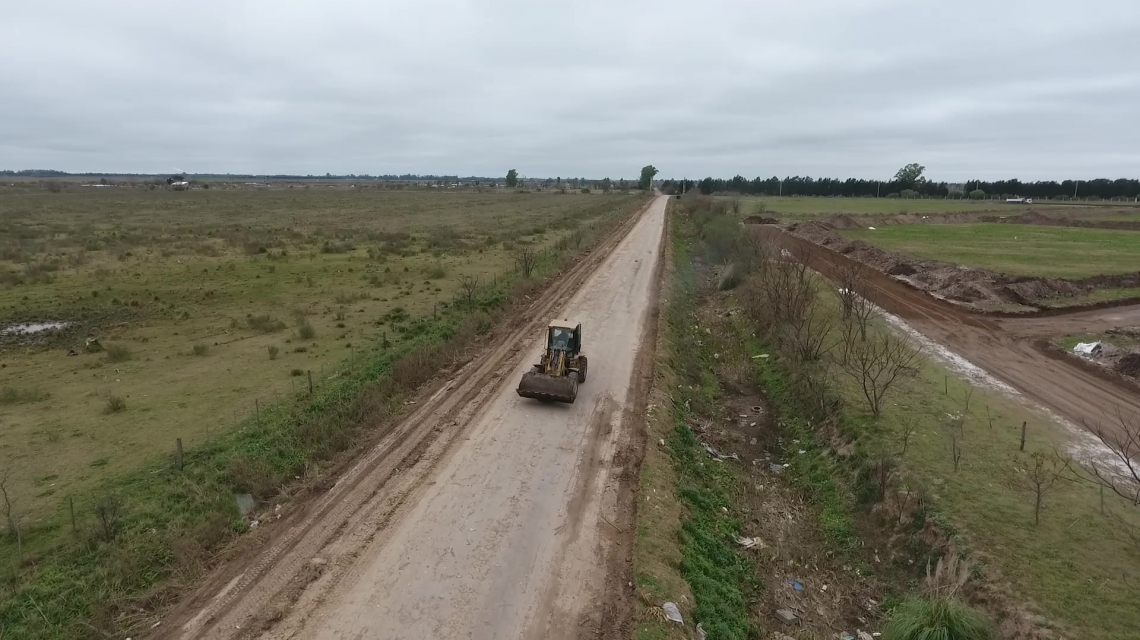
(829, 330, 1140, 640)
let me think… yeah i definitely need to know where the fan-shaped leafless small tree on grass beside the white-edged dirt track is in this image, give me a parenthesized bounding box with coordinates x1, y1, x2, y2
(836, 332, 925, 416)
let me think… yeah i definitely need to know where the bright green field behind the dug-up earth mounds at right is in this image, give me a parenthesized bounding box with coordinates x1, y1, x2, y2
(841, 224, 1140, 278)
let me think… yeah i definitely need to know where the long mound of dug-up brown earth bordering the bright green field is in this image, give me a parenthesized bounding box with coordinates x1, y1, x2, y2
(788, 220, 1140, 313)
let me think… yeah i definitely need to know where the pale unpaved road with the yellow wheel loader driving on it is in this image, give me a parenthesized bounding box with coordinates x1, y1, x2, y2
(157, 197, 667, 640)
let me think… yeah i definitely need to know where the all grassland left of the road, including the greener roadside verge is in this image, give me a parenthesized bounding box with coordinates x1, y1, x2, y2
(0, 182, 643, 640)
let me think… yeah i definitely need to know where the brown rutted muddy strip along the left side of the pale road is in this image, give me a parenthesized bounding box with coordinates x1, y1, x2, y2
(157, 196, 663, 638)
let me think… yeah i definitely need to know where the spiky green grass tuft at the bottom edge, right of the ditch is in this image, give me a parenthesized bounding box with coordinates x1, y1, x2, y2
(882, 596, 994, 640)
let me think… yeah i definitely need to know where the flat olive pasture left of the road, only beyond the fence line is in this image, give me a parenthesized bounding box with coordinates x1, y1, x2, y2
(0, 187, 636, 522)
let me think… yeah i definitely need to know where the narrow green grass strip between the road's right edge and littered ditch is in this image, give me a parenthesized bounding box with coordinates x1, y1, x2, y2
(634, 207, 759, 640)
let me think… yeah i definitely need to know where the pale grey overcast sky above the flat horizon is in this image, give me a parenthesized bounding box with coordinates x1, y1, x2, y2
(0, 0, 1140, 180)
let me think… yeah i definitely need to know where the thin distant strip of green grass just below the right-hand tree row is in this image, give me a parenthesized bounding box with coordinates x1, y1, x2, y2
(722, 196, 1010, 220)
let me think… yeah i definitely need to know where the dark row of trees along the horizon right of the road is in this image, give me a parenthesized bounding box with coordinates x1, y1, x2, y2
(661, 163, 1140, 200)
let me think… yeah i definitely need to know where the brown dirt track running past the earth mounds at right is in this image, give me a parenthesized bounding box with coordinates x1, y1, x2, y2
(750, 226, 1140, 444)
